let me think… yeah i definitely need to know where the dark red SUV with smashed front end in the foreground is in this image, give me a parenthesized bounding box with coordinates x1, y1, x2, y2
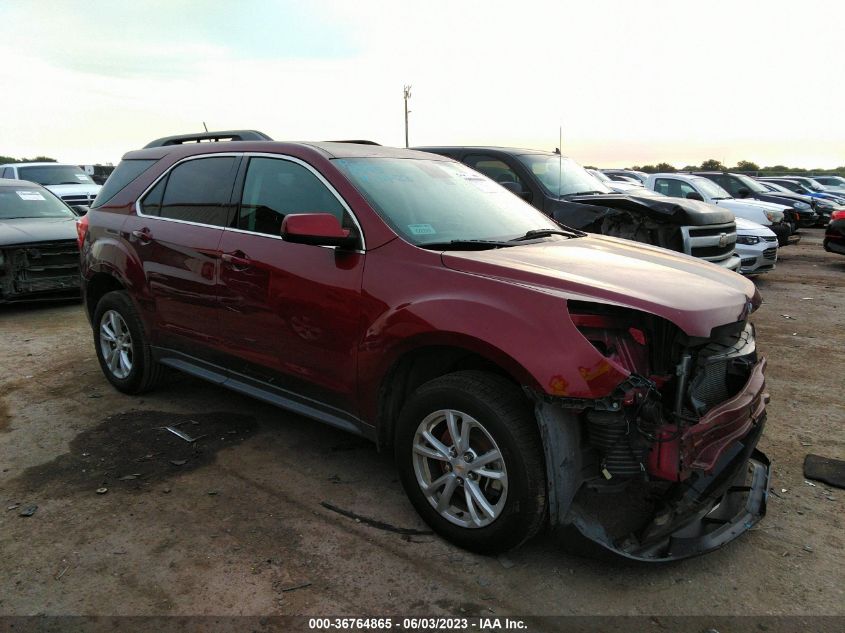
(81, 132, 770, 561)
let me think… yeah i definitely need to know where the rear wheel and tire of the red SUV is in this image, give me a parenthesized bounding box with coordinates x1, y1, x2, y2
(92, 290, 162, 394)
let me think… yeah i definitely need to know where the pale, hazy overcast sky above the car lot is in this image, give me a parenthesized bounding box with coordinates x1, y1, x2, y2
(0, 0, 845, 168)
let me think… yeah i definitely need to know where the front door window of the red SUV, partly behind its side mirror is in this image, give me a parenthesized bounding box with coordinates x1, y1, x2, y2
(234, 158, 352, 235)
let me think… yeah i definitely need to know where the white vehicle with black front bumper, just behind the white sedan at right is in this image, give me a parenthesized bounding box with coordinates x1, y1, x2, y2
(646, 172, 792, 246)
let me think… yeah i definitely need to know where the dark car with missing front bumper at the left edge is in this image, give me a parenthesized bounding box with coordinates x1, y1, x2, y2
(0, 178, 79, 303)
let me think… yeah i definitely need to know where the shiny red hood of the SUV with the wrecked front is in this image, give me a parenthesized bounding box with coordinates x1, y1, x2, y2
(442, 236, 760, 337)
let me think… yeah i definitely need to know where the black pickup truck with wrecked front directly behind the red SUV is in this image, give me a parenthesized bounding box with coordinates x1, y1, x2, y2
(415, 147, 739, 270)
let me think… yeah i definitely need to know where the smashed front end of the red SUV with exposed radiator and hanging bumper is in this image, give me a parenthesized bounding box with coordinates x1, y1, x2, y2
(536, 304, 770, 562)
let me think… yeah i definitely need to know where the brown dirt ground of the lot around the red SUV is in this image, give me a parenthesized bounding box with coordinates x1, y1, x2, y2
(0, 229, 845, 616)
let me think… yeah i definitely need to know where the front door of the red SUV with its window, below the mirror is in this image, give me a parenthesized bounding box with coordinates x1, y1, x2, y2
(220, 156, 365, 414)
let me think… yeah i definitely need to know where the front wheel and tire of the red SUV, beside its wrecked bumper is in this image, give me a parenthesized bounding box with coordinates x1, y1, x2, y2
(395, 371, 546, 554)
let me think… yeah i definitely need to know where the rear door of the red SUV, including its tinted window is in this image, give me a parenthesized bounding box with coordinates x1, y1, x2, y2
(124, 154, 241, 361)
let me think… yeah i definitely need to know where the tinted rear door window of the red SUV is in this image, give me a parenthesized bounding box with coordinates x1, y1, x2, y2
(148, 156, 238, 226)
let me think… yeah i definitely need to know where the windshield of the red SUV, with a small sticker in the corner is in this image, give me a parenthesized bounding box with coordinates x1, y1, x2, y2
(333, 158, 560, 246)
